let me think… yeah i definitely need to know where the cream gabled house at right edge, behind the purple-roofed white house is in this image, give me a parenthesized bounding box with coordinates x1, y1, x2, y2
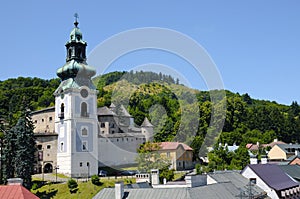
(268, 144, 300, 161)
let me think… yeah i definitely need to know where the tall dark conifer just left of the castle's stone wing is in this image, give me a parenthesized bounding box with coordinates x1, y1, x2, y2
(12, 108, 36, 189)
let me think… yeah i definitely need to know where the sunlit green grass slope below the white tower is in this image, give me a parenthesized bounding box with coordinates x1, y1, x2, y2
(31, 179, 135, 199)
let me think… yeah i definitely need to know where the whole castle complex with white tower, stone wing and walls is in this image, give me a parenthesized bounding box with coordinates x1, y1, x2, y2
(32, 20, 153, 177)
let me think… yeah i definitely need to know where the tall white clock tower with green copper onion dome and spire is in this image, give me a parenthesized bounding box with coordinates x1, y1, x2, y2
(54, 14, 98, 177)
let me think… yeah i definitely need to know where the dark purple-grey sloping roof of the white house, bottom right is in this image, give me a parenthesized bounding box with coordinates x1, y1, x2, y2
(247, 164, 299, 191)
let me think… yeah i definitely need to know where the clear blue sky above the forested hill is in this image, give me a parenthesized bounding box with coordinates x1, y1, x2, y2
(0, 0, 300, 104)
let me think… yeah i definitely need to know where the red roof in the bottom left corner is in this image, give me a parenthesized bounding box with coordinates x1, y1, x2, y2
(0, 185, 39, 199)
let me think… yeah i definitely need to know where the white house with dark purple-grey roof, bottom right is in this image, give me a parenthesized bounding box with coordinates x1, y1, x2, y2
(241, 164, 300, 199)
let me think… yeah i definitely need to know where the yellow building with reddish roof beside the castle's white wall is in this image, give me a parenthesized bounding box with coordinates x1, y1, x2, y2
(158, 142, 193, 171)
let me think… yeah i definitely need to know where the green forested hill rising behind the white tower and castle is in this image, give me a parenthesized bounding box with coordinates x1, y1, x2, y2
(0, 72, 300, 159)
